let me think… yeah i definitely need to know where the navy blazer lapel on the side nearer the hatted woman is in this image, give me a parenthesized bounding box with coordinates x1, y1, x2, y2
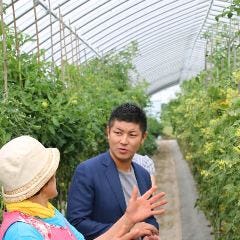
(103, 153, 126, 213)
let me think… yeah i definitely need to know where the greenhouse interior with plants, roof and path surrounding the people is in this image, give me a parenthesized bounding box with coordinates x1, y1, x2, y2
(0, 0, 240, 240)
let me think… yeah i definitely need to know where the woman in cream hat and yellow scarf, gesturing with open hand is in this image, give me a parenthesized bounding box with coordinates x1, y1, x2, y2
(0, 136, 166, 240)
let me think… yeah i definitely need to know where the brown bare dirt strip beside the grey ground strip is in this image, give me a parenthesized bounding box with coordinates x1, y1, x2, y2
(153, 141, 182, 240)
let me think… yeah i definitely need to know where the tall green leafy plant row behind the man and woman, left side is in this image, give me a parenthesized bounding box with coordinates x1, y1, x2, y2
(0, 22, 161, 218)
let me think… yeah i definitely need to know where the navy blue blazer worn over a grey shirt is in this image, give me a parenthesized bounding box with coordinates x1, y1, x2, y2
(67, 152, 158, 240)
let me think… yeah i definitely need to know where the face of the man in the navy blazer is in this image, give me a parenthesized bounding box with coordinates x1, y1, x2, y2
(107, 120, 146, 162)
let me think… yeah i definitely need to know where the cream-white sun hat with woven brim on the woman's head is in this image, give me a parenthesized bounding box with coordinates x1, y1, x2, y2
(0, 136, 60, 203)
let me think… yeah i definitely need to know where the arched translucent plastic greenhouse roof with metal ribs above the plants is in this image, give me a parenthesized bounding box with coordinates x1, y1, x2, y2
(3, 0, 230, 94)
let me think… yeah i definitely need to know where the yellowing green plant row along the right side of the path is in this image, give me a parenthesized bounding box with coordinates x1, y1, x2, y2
(161, 22, 240, 240)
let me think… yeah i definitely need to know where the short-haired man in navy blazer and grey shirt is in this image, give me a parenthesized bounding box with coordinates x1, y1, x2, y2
(67, 103, 159, 240)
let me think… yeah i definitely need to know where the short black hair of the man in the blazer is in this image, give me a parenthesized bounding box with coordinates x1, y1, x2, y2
(108, 103, 147, 133)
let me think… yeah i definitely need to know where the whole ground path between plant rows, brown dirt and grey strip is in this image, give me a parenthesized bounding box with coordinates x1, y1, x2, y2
(153, 140, 213, 240)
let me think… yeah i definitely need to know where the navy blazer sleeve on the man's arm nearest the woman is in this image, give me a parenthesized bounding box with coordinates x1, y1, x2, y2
(66, 164, 113, 240)
